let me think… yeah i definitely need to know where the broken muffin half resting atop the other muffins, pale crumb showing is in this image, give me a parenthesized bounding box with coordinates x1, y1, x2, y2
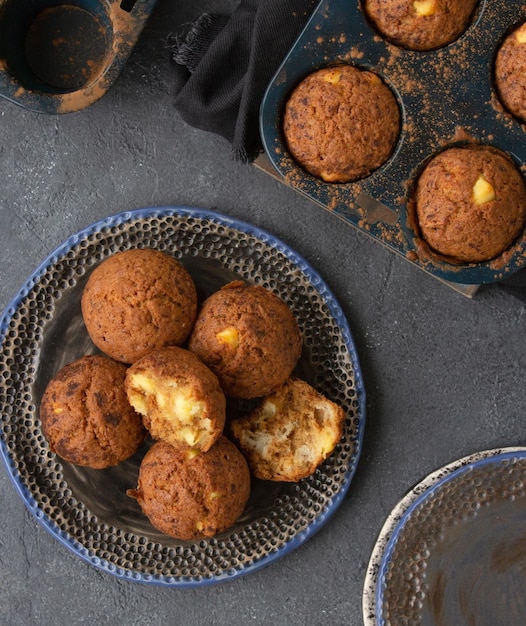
(125, 346, 226, 451)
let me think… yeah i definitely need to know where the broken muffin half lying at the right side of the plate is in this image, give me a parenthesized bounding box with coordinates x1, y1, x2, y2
(231, 378, 345, 482)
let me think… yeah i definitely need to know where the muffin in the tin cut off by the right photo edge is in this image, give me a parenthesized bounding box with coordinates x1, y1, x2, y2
(495, 23, 526, 122)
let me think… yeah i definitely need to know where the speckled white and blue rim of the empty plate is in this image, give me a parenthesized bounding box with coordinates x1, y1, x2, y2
(362, 446, 526, 626)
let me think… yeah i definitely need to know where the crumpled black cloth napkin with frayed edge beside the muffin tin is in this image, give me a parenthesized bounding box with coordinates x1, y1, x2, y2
(168, 0, 318, 161)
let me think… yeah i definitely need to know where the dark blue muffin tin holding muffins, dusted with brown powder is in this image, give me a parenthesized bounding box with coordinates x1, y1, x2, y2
(260, 0, 526, 285)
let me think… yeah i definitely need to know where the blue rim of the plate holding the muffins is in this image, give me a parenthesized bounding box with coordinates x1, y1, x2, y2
(0, 205, 366, 588)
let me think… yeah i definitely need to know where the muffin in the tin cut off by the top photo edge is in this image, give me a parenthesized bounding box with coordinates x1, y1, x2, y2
(364, 0, 477, 50)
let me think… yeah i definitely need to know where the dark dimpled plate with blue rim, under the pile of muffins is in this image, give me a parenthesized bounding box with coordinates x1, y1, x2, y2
(0, 207, 365, 587)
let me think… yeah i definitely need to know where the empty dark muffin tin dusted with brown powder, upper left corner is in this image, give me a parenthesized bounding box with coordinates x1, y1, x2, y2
(0, 0, 156, 114)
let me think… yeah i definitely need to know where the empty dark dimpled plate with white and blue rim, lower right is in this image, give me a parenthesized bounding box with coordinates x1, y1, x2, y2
(363, 448, 526, 626)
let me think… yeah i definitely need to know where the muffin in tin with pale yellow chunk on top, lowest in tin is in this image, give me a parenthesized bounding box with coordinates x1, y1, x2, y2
(414, 145, 526, 263)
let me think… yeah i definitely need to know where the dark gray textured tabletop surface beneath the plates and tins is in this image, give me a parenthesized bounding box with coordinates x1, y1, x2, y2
(0, 0, 526, 626)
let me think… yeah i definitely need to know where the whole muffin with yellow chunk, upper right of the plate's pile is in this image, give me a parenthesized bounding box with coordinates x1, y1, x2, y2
(188, 281, 302, 399)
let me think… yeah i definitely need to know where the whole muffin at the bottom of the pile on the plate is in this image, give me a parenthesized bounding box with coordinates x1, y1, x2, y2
(128, 437, 250, 540)
